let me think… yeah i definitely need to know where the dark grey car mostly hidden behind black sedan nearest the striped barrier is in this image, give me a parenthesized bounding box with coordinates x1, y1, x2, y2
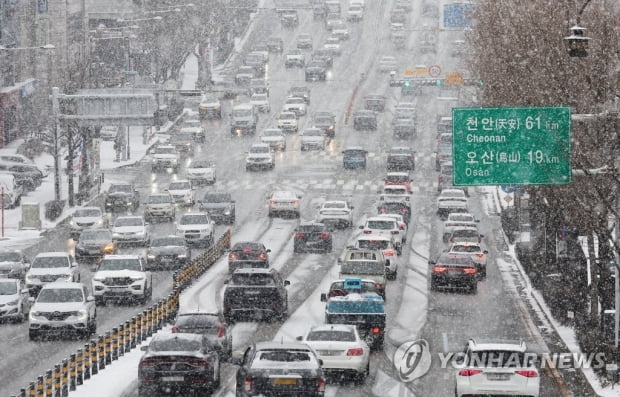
(172, 312, 232, 360)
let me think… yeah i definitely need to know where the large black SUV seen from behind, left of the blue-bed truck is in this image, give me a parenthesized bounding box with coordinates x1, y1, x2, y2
(223, 268, 290, 324)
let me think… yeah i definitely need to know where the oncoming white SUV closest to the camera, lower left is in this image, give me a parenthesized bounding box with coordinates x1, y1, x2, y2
(28, 281, 97, 340)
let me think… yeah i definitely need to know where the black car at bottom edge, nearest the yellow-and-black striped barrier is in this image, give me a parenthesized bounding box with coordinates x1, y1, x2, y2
(138, 332, 220, 397)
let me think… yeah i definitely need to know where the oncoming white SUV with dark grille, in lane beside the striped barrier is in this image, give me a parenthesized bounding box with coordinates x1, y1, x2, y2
(92, 255, 153, 305)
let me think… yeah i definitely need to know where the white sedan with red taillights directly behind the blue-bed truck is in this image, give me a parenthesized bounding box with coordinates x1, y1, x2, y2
(297, 324, 370, 384)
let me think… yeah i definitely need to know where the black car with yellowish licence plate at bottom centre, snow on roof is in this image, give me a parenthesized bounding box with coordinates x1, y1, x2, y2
(235, 342, 325, 397)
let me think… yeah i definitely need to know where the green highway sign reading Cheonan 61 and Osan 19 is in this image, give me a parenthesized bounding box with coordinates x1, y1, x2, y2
(452, 107, 571, 186)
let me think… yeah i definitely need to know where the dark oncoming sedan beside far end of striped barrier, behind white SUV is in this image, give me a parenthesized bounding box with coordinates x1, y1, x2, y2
(146, 236, 191, 269)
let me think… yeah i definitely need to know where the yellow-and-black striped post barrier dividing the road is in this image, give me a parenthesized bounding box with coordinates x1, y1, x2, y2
(12, 229, 232, 397)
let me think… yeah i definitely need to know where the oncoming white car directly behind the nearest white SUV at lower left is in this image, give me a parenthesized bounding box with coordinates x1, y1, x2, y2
(26, 252, 80, 296)
